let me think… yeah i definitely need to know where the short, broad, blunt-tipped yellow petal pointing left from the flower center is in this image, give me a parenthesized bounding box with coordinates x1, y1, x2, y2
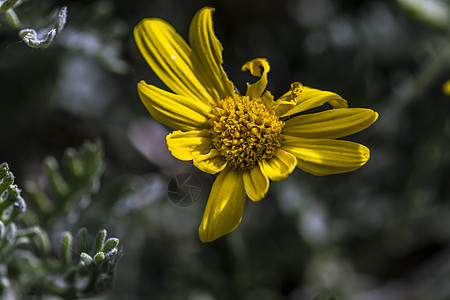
(166, 129, 213, 160)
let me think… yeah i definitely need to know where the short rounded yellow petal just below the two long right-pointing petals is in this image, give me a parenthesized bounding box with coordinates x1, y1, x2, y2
(262, 149, 297, 181)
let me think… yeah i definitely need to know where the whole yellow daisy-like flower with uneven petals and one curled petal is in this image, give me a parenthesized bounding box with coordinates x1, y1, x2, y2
(134, 7, 378, 242)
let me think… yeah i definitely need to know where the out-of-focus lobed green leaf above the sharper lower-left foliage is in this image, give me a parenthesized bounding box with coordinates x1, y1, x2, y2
(26, 141, 103, 228)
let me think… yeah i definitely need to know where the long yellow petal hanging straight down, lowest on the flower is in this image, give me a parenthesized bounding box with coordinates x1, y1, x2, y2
(198, 168, 245, 243)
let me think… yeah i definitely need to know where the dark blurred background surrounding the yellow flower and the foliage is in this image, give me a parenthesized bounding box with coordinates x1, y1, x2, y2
(0, 0, 450, 300)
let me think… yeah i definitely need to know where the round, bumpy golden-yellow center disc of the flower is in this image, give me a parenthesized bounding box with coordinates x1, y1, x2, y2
(209, 95, 284, 170)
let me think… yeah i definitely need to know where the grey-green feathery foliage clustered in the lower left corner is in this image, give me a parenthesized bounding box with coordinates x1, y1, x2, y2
(0, 143, 122, 299)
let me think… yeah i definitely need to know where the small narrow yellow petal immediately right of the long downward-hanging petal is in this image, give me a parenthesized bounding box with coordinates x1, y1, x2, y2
(243, 164, 269, 201)
